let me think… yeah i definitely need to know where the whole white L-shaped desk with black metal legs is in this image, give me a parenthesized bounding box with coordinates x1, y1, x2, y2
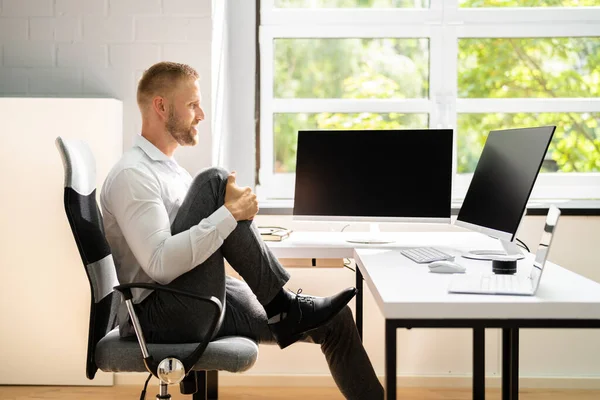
(269, 232, 600, 400)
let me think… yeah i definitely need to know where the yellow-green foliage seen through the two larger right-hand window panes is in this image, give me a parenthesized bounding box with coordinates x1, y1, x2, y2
(458, 38, 600, 172)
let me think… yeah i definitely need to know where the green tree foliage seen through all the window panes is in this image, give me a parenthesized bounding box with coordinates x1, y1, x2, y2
(273, 0, 600, 172)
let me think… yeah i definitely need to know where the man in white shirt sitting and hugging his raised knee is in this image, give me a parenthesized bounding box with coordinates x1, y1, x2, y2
(100, 62, 383, 400)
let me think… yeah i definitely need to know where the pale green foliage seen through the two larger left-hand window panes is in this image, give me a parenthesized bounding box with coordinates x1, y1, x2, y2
(273, 39, 429, 172)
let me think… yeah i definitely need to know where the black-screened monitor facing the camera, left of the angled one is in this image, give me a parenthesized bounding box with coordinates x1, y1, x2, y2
(293, 129, 452, 243)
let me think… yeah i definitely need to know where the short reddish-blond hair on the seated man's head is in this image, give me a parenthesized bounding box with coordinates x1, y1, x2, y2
(137, 61, 200, 109)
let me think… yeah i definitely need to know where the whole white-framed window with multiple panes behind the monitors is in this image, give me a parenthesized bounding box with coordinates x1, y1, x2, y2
(259, 0, 600, 199)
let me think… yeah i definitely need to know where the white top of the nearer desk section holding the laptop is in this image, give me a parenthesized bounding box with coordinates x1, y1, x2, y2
(354, 232, 600, 319)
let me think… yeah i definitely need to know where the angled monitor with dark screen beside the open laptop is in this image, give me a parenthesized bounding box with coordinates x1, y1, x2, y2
(455, 126, 556, 260)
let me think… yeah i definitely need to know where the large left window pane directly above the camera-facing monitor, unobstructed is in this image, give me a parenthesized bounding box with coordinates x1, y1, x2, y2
(273, 39, 429, 99)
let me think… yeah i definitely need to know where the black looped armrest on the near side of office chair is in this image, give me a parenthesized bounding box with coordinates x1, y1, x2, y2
(114, 283, 223, 378)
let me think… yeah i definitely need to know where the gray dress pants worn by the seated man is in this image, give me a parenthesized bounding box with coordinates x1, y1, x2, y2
(136, 168, 383, 400)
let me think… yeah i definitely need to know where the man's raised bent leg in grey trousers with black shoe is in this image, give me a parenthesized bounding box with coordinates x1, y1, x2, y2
(152, 168, 356, 348)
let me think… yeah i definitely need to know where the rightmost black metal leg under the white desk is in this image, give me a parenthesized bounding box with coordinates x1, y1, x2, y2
(502, 328, 519, 400)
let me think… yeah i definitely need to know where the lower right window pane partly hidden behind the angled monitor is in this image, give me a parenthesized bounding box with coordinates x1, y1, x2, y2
(457, 113, 600, 173)
